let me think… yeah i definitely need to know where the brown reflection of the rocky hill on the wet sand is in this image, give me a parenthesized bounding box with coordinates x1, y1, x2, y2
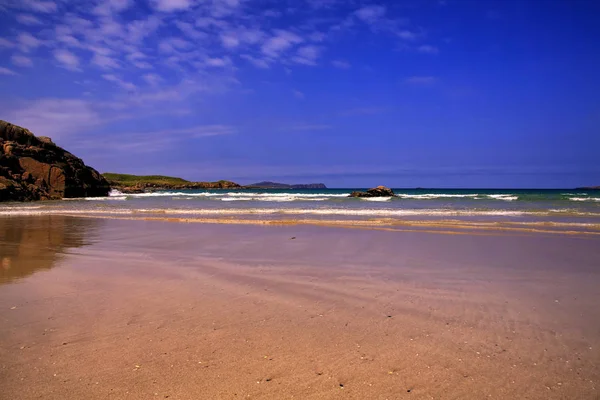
(0, 215, 102, 284)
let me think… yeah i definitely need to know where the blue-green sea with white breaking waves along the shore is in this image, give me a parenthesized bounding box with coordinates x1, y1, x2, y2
(0, 188, 600, 232)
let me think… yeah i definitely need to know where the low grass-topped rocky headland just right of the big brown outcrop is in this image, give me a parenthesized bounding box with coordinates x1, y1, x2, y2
(102, 172, 242, 193)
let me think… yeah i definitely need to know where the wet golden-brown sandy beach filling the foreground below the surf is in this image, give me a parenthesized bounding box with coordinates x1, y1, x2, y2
(0, 216, 600, 399)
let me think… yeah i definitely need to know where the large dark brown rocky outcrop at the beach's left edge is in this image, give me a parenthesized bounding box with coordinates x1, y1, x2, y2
(0, 120, 110, 201)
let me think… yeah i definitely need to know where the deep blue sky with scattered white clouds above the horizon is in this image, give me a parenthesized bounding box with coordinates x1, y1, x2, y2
(0, 0, 600, 188)
